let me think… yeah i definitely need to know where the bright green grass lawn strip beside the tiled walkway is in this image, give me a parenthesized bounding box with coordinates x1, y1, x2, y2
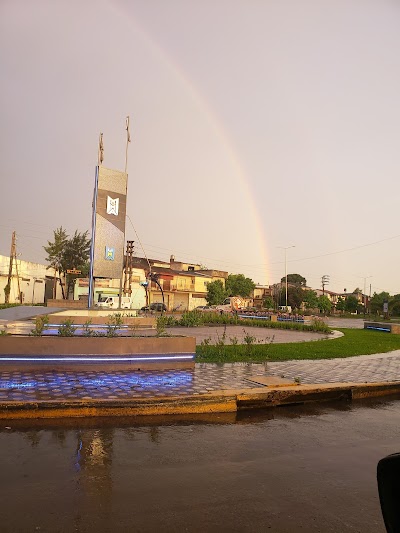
(196, 329, 400, 363)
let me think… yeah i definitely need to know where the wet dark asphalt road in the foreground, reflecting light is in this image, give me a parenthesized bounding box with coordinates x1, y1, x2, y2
(0, 400, 400, 533)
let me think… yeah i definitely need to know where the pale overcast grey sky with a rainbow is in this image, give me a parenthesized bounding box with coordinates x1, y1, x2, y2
(0, 0, 400, 294)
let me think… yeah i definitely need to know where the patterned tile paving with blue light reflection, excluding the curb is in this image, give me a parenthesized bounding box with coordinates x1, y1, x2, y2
(0, 350, 400, 402)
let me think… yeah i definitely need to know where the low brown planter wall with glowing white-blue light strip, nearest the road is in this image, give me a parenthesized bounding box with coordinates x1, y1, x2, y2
(0, 335, 196, 372)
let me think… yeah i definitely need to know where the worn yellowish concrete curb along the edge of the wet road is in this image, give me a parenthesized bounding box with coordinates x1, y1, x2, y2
(0, 382, 400, 420)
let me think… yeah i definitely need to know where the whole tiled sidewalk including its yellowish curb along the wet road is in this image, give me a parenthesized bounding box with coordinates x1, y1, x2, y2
(0, 350, 400, 419)
